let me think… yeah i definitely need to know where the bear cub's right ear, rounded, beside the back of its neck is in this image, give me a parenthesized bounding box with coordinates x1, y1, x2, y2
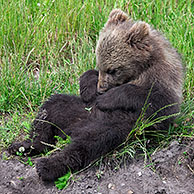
(127, 22, 150, 45)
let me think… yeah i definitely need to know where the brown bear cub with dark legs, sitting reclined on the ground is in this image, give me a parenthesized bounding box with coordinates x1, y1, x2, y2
(9, 9, 182, 181)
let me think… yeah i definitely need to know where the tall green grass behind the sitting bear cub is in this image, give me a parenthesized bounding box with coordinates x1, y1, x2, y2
(0, 0, 194, 155)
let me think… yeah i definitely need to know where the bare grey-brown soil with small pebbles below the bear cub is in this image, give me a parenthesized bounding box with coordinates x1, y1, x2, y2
(0, 139, 194, 194)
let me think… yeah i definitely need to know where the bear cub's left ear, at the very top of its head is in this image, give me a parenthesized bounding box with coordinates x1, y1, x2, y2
(105, 9, 128, 26)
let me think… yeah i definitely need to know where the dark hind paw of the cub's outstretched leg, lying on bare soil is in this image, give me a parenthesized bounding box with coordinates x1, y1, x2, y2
(36, 158, 67, 182)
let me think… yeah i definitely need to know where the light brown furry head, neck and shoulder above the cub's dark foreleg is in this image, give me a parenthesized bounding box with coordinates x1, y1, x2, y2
(96, 9, 182, 101)
